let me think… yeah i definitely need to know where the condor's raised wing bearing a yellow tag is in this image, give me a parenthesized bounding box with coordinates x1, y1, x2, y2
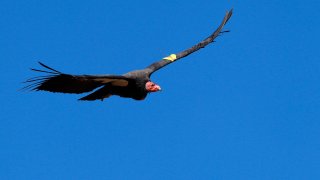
(146, 9, 232, 76)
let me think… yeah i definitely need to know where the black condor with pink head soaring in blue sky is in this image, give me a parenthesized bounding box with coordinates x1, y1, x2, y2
(24, 9, 232, 101)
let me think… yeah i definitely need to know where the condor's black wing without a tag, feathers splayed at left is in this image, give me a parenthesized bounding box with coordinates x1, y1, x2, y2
(23, 62, 130, 94)
